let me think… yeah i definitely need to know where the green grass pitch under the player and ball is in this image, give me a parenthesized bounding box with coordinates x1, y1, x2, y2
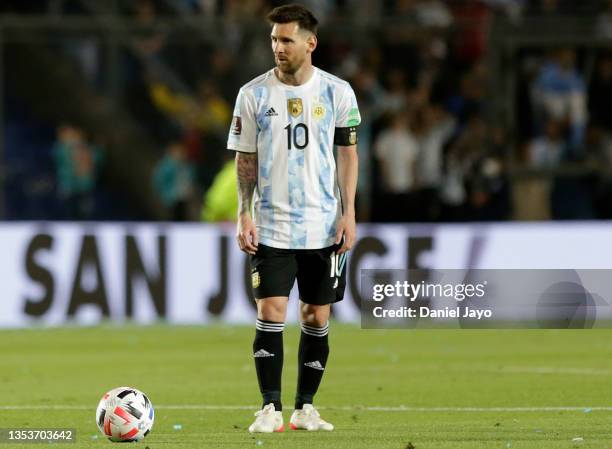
(0, 323, 612, 449)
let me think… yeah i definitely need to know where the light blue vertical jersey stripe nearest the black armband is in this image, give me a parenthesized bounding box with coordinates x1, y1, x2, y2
(319, 79, 338, 236)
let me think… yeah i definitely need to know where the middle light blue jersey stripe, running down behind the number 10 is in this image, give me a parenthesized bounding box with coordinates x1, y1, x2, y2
(285, 90, 308, 248)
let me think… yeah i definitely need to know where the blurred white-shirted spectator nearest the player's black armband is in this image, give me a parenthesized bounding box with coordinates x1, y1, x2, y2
(374, 111, 418, 222)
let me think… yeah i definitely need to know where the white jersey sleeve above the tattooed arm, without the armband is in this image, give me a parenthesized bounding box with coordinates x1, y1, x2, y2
(227, 89, 257, 153)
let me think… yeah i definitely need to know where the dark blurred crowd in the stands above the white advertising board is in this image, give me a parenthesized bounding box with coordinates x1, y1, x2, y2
(0, 0, 612, 223)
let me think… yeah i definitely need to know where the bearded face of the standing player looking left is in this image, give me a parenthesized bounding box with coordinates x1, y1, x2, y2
(270, 22, 316, 74)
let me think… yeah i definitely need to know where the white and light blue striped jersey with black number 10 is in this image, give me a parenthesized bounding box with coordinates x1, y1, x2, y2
(227, 67, 361, 249)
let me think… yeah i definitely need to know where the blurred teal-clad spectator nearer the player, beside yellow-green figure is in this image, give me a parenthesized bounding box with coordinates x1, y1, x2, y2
(153, 142, 195, 221)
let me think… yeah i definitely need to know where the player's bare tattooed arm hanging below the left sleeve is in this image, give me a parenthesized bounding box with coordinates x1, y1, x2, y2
(236, 151, 258, 254)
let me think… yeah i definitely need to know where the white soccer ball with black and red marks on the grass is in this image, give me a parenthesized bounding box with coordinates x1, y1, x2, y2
(96, 387, 154, 442)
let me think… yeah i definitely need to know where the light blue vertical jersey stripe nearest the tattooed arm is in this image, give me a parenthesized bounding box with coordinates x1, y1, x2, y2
(254, 86, 274, 229)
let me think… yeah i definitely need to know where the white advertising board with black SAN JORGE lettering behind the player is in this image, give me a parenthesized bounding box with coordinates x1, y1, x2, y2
(0, 222, 612, 327)
